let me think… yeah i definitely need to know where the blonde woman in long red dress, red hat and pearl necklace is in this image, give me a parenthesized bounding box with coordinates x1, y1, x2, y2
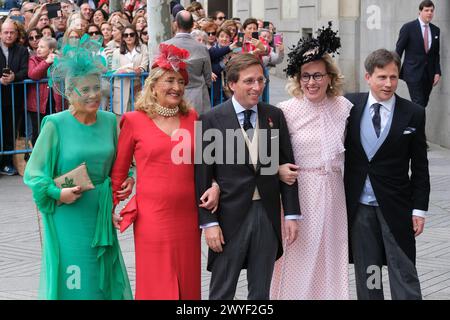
(112, 44, 219, 300)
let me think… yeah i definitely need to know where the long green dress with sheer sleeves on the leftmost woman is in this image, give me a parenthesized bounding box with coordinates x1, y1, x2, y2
(24, 111, 132, 300)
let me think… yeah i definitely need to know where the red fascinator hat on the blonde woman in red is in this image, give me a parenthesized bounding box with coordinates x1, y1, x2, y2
(152, 43, 189, 84)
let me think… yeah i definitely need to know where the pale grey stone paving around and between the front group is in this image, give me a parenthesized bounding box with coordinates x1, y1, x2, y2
(0, 77, 450, 300)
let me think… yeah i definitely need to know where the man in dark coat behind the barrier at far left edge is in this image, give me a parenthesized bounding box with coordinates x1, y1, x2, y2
(0, 20, 28, 175)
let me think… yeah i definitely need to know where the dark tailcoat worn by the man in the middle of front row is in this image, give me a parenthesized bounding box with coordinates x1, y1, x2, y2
(195, 99, 300, 270)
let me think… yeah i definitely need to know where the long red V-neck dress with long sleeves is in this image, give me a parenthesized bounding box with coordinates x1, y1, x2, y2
(111, 110, 201, 300)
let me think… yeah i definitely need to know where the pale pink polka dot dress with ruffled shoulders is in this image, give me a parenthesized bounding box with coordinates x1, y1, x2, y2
(271, 97, 352, 300)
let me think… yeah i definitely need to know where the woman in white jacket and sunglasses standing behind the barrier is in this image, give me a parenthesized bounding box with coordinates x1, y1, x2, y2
(112, 26, 149, 115)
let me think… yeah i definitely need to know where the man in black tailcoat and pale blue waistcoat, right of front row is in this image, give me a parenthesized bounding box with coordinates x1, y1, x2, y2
(344, 49, 430, 300)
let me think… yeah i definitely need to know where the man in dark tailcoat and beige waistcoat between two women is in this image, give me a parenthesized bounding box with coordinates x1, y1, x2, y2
(196, 54, 300, 300)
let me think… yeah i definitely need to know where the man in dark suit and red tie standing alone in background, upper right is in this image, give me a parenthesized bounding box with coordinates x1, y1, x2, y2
(396, 0, 441, 107)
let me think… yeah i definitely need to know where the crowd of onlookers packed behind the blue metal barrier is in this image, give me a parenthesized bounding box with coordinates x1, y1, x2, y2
(1, 0, 284, 175)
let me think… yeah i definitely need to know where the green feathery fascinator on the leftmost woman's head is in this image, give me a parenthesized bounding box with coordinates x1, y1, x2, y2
(47, 34, 107, 98)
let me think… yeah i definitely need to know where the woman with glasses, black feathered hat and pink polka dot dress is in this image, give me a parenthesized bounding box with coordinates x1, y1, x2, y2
(271, 23, 353, 300)
